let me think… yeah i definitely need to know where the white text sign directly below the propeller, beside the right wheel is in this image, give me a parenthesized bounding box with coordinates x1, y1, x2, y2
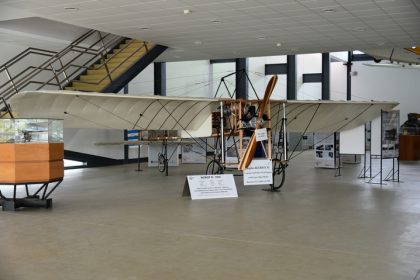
(244, 159, 273, 186)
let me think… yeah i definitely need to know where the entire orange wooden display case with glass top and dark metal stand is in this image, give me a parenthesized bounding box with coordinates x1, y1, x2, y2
(0, 119, 64, 210)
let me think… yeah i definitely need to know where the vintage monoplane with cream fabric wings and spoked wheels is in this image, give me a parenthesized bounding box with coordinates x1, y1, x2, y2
(4, 76, 398, 189)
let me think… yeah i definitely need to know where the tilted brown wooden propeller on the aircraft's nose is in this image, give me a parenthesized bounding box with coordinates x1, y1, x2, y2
(238, 75, 278, 171)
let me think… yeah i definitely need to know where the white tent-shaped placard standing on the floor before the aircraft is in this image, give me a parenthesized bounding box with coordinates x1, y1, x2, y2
(182, 174, 238, 200)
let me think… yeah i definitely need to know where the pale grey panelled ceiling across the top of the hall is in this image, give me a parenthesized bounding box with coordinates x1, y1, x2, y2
(0, 0, 420, 61)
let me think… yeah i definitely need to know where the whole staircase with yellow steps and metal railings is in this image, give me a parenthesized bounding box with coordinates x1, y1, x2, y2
(0, 30, 166, 100)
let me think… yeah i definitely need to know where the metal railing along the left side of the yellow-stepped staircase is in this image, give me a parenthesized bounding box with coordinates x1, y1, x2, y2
(0, 30, 126, 100)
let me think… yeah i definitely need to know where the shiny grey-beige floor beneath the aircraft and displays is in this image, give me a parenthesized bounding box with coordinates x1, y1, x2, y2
(0, 154, 420, 280)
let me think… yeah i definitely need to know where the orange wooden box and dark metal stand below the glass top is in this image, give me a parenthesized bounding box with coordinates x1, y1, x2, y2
(0, 143, 64, 211)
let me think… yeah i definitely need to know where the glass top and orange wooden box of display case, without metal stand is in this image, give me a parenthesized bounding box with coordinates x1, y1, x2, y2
(0, 119, 64, 184)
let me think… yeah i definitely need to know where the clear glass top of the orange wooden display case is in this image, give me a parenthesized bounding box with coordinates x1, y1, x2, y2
(0, 119, 63, 143)
